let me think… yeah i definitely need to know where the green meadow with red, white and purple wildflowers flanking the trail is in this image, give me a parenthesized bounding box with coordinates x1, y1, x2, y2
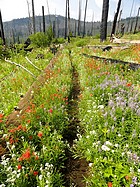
(0, 35, 140, 187)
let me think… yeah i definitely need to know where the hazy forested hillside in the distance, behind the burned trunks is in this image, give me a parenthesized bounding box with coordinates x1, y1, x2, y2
(3, 15, 140, 43)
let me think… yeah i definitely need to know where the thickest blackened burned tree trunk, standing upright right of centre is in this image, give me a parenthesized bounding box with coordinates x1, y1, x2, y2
(100, 0, 109, 42)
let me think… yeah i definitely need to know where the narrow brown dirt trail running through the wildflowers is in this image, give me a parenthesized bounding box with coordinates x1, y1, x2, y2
(64, 50, 88, 187)
